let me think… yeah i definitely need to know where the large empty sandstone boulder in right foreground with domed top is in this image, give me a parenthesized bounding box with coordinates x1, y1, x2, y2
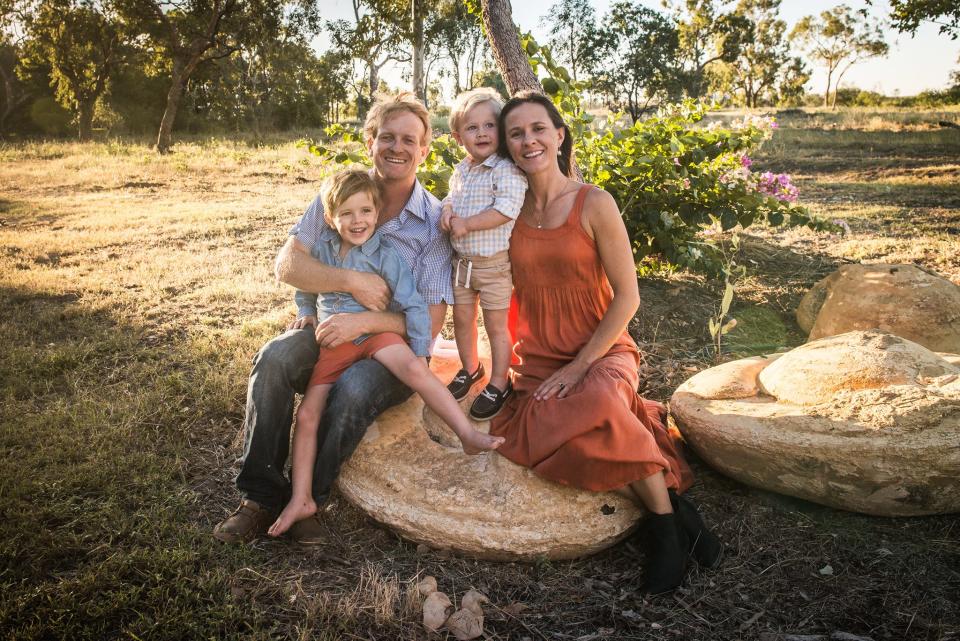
(670, 331, 960, 516)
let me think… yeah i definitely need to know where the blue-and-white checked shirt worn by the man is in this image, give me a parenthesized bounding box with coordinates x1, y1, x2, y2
(290, 180, 453, 305)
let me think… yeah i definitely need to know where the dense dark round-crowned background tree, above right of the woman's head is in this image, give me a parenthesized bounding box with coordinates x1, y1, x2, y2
(583, 0, 682, 120)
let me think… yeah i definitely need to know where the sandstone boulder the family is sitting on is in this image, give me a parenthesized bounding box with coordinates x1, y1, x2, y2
(337, 338, 640, 560)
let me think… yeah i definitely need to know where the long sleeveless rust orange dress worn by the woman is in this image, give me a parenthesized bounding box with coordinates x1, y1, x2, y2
(490, 185, 693, 491)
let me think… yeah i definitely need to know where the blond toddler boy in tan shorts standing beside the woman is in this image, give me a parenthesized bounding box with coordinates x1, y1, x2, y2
(440, 87, 527, 420)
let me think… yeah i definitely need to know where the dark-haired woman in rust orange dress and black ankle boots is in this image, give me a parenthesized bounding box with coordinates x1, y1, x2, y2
(490, 92, 722, 594)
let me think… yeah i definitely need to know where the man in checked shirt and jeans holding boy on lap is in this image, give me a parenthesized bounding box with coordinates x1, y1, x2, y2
(213, 93, 453, 544)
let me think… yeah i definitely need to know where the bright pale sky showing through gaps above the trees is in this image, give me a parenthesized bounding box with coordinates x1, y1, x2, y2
(317, 0, 960, 96)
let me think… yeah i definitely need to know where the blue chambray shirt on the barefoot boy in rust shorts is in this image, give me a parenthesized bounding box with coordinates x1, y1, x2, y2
(294, 227, 432, 356)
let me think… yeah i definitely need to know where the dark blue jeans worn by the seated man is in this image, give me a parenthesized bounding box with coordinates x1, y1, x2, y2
(236, 327, 413, 509)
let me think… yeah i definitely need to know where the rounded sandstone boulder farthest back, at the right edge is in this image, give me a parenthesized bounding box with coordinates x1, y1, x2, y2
(797, 265, 960, 354)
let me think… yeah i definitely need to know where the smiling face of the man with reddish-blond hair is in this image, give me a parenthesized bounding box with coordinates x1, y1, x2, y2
(367, 111, 428, 181)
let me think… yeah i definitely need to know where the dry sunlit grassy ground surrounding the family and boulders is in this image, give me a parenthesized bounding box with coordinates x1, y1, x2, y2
(0, 112, 960, 641)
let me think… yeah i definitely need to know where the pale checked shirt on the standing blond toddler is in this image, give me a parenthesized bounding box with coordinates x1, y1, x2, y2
(443, 154, 527, 256)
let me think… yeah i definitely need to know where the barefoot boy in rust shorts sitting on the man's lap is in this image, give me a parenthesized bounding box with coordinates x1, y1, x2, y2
(268, 169, 503, 536)
